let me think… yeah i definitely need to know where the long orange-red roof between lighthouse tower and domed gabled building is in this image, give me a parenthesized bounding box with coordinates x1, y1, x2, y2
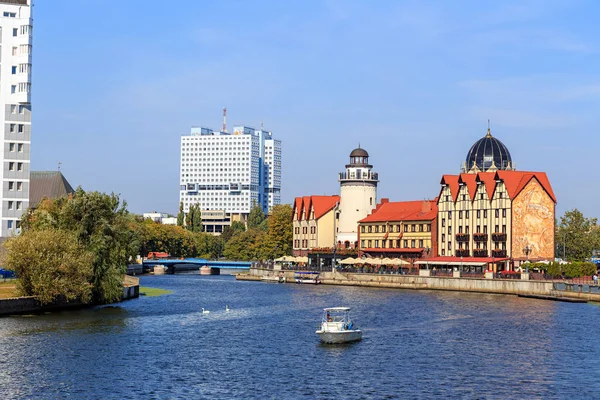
(358, 200, 437, 222)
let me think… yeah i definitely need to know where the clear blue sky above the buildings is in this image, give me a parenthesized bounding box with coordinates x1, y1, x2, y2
(32, 0, 600, 217)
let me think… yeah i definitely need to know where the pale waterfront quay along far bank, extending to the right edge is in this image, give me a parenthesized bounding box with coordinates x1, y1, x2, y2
(236, 268, 600, 301)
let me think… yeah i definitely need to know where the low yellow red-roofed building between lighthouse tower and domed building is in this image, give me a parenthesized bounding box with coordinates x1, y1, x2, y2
(359, 199, 438, 259)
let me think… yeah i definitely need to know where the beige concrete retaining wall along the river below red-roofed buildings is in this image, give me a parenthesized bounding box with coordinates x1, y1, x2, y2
(236, 268, 552, 296)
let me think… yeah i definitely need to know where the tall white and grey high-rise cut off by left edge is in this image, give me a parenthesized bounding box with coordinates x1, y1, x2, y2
(0, 0, 33, 237)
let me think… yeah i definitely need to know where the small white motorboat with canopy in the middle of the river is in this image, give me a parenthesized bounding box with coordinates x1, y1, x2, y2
(316, 307, 362, 343)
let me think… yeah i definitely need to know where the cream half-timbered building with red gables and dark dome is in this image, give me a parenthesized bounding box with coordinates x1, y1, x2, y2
(437, 130, 556, 269)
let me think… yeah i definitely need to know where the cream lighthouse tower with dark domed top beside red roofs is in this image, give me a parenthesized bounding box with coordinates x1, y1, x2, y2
(336, 145, 379, 248)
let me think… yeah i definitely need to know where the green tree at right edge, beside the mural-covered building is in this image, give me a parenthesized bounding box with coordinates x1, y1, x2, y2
(555, 209, 600, 261)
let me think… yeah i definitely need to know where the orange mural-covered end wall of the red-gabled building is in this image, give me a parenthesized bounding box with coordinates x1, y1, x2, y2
(512, 178, 555, 259)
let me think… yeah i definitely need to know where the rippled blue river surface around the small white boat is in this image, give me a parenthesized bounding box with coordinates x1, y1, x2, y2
(0, 274, 600, 399)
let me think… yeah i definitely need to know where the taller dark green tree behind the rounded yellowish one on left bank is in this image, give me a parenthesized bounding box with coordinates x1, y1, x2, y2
(22, 187, 136, 303)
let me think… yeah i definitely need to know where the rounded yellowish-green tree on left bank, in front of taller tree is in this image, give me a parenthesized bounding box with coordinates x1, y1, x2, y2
(3, 229, 94, 304)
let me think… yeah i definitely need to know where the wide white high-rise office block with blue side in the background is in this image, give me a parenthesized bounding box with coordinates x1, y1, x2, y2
(179, 124, 281, 234)
